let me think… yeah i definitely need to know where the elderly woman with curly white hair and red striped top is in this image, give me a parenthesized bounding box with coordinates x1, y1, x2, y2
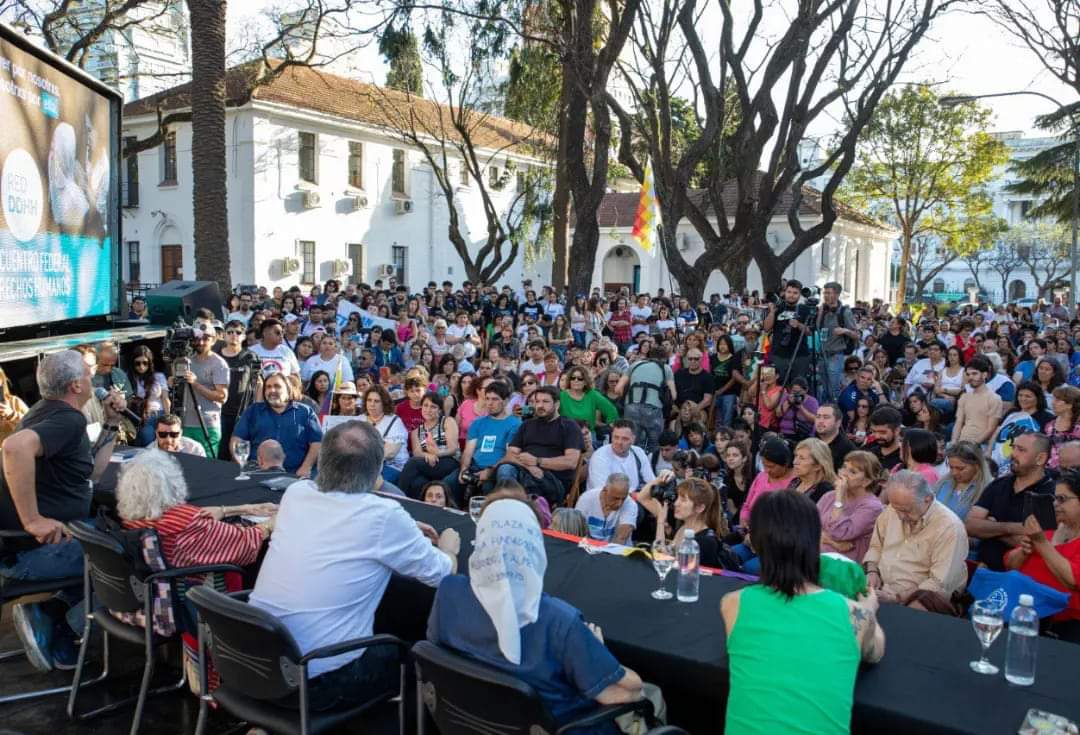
(117, 449, 278, 568)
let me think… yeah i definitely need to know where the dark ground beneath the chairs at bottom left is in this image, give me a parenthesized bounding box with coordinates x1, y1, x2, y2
(0, 605, 397, 735)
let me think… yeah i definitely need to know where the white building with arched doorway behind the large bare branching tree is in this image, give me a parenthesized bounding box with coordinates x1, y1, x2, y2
(574, 186, 896, 303)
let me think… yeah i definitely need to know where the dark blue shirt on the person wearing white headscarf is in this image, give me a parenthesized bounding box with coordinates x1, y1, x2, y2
(428, 574, 626, 735)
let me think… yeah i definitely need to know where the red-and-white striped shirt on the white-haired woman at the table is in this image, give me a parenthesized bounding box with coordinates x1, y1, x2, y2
(124, 503, 262, 569)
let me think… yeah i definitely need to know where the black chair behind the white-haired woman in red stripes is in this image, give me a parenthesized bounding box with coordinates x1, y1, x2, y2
(67, 521, 243, 735)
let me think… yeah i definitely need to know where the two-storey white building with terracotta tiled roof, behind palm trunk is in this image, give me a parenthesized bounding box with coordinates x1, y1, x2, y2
(123, 61, 550, 288)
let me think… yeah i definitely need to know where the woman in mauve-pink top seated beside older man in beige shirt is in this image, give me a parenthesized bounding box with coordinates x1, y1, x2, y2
(818, 451, 883, 563)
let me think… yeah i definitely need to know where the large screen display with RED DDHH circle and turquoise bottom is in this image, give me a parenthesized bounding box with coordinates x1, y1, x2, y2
(0, 35, 117, 329)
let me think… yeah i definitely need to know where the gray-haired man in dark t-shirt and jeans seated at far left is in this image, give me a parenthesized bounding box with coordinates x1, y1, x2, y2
(0, 350, 125, 671)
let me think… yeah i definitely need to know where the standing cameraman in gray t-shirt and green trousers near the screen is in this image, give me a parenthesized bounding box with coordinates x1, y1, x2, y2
(173, 324, 229, 457)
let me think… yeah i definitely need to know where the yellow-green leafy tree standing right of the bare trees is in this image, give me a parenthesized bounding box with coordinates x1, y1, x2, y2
(843, 84, 1008, 300)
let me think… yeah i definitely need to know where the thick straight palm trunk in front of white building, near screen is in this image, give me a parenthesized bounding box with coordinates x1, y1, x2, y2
(187, 0, 232, 292)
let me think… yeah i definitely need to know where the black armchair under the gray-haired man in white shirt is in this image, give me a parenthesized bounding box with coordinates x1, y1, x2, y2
(188, 587, 408, 735)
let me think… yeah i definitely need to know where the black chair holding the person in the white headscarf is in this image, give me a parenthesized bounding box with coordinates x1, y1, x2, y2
(413, 641, 652, 735)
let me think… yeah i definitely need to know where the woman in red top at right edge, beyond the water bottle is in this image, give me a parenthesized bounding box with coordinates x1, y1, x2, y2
(1005, 471, 1080, 643)
